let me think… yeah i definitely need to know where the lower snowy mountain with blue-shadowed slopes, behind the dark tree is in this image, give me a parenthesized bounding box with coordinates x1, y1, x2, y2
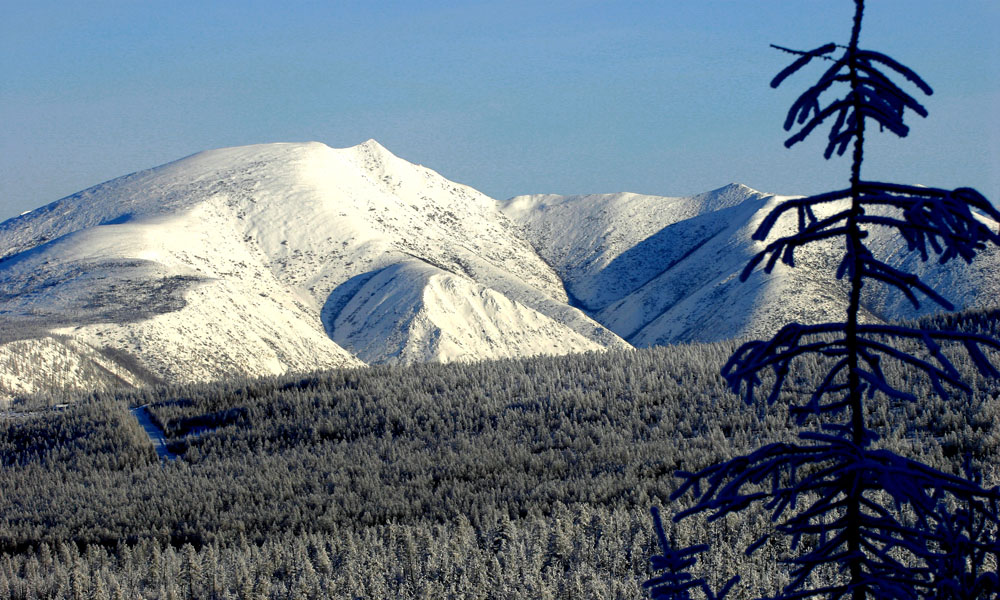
(503, 184, 1000, 346)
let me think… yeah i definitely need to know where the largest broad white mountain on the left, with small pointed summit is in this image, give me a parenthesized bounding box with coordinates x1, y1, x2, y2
(0, 141, 626, 398)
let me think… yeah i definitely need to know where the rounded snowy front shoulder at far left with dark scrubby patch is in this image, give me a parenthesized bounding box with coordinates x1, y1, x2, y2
(0, 190, 368, 392)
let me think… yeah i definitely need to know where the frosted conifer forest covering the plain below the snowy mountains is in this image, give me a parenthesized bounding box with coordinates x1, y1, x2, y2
(0, 312, 1000, 599)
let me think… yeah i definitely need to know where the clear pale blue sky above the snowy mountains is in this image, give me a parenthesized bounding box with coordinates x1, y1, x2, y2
(0, 0, 1000, 220)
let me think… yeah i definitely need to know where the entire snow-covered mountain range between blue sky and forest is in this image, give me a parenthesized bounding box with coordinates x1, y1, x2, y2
(0, 140, 1000, 396)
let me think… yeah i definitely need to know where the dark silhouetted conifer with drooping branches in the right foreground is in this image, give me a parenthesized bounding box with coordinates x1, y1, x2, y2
(651, 0, 1000, 600)
